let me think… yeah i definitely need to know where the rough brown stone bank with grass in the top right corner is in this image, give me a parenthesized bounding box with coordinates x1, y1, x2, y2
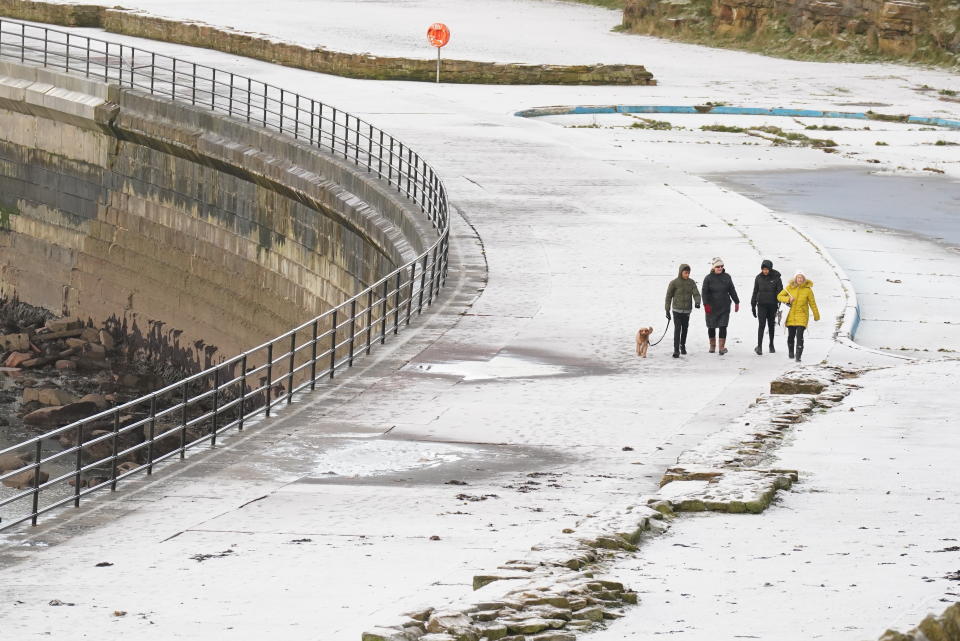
(623, 0, 960, 66)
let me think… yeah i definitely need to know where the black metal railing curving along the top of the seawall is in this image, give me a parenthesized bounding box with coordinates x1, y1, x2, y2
(0, 19, 449, 530)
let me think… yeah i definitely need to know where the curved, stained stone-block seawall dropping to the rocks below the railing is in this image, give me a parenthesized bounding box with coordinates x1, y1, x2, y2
(0, 63, 436, 366)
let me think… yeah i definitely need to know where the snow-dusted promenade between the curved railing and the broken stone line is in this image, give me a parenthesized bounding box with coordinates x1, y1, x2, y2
(0, 2, 960, 641)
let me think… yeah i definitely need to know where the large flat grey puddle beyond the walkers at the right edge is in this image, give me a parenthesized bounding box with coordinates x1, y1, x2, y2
(704, 168, 960, 246)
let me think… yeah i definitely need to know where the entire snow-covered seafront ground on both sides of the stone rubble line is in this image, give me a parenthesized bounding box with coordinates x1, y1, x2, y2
(0, 0, 960, 641)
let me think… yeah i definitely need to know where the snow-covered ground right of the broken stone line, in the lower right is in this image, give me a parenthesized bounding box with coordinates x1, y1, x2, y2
(590, 362, 960, 641)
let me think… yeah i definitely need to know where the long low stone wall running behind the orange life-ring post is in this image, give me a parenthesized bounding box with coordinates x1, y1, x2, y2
(0, 0, 656, 85)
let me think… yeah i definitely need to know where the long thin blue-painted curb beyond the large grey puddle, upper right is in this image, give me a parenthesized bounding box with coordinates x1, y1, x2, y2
(514, 105, 960, 129)
